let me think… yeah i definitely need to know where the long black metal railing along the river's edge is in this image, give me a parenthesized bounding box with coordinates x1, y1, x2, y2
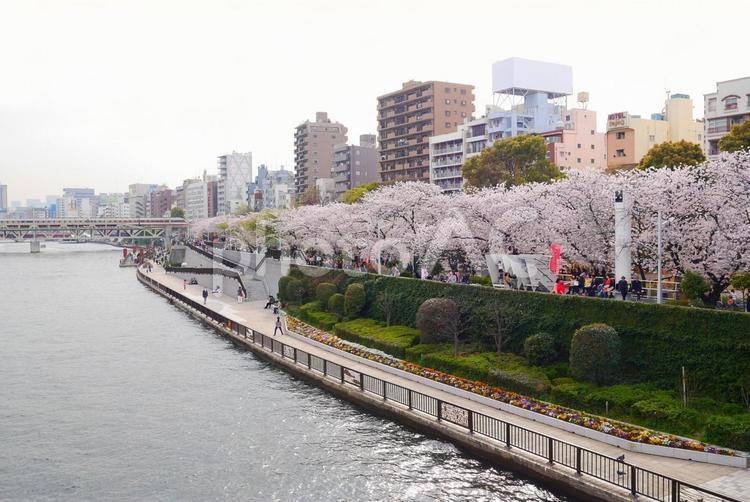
(138, 269, 740, 502)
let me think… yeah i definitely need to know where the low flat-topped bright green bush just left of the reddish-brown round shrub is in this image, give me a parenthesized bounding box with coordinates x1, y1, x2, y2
(335, 319, 419, 359)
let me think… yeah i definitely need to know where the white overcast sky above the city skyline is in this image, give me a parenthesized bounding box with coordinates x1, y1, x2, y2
(0, 0, 750, 201)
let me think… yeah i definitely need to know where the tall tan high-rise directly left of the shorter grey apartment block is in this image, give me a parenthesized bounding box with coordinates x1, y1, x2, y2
(294, 112, 347, 193)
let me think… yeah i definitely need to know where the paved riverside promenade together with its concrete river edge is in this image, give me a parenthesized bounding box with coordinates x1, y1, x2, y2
(140, 266, 750, 501)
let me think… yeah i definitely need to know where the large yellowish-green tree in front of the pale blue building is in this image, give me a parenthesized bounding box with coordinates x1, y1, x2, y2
(461, 135, 561, 188)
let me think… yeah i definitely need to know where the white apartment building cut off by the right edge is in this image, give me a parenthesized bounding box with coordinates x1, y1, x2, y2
(703, 77, 750, 158)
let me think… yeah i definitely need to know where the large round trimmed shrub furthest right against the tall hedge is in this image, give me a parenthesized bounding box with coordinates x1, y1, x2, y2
(570, 324, 621, 385)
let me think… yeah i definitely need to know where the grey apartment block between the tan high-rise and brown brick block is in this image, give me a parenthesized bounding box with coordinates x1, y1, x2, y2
(331, 134, 380, 200)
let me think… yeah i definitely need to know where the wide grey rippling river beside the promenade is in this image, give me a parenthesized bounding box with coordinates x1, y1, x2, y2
(0, 243, 567, 501)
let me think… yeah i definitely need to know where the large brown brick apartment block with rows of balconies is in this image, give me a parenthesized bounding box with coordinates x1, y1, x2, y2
(378, 80, 474, 182)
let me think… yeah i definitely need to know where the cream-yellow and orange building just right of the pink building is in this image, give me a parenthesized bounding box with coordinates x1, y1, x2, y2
(607, 94, 703, 170)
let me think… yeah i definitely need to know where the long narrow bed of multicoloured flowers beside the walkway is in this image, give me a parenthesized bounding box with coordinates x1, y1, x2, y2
(287, 317, 738, 456)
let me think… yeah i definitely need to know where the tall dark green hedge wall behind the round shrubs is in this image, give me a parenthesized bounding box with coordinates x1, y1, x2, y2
(284, 267, 750, 402)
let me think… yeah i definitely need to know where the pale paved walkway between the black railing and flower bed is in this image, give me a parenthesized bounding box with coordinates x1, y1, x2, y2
(142, 266, 750, 501)
